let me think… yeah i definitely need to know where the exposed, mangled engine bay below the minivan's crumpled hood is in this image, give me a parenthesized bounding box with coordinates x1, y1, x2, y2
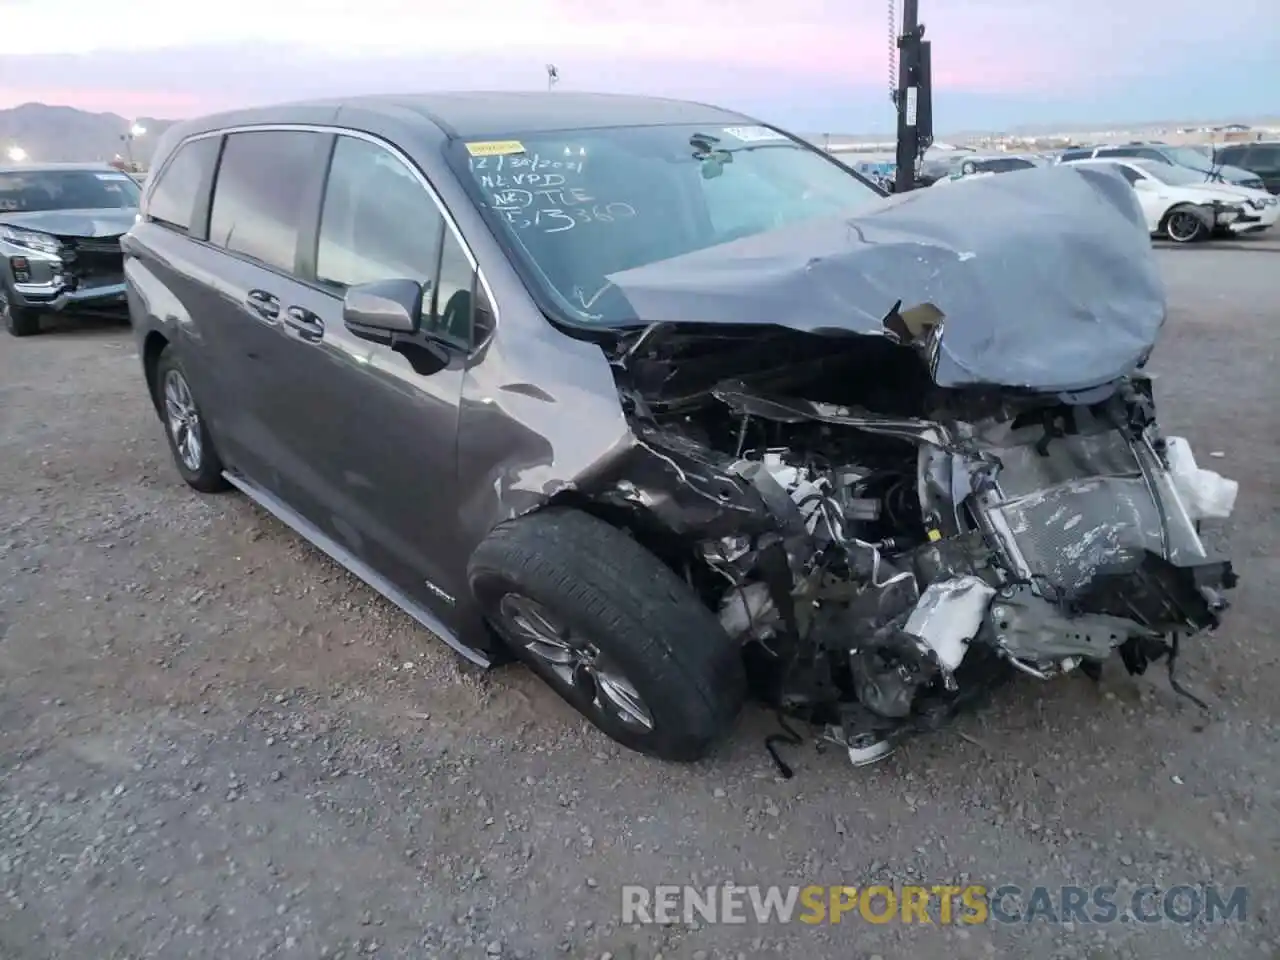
(611, 330, 1236, 764)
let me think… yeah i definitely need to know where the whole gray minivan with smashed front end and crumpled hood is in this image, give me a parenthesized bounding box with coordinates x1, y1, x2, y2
(124, 92, 1235, 763)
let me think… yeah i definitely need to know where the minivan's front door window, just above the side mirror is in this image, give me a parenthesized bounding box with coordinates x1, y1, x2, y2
(316, 137, 444, 291)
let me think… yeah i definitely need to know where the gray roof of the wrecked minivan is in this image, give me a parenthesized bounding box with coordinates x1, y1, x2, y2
(168, 91, 756, 138)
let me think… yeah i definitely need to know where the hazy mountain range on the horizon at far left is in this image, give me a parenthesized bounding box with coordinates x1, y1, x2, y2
(0, 104, 174, 165)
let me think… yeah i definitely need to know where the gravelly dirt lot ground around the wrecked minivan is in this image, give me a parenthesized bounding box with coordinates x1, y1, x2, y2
(0, 250, 1280, 960)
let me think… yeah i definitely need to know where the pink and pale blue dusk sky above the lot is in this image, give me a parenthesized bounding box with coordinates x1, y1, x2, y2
(0, 0, 1280, 132)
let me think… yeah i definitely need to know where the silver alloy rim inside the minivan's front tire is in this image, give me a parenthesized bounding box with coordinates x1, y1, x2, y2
(498, 593, 654, 732)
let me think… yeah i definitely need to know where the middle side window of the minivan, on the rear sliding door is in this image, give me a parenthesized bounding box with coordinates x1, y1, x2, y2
(209, 131, 324, 273)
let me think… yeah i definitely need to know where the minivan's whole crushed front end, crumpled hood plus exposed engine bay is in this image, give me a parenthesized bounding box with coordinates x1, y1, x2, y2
(540, 168, 1235, 762)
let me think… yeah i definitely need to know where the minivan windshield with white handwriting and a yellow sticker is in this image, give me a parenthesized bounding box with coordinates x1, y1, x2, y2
(453, 124, 882, 325)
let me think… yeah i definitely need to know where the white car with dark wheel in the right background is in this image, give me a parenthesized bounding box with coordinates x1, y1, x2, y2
(1064, 159, 1280, 243)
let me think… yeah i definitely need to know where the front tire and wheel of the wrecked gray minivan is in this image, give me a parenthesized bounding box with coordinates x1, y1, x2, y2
(468, 508, 746, 762)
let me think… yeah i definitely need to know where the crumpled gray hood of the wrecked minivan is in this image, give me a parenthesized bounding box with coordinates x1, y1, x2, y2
(609, 166, 1165, 392)
